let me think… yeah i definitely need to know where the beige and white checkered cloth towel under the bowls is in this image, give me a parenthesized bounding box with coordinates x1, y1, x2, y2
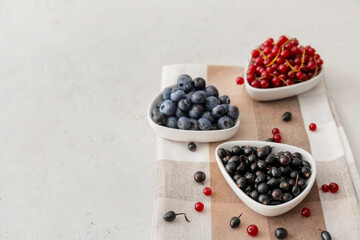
(152, 65, 360, 240)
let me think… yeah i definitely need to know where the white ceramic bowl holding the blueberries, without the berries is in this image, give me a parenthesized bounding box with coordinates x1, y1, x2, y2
(147, 93, 240, 142)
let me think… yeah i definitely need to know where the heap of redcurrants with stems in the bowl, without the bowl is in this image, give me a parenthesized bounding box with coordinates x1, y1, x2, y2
(246, 35, 323, 88)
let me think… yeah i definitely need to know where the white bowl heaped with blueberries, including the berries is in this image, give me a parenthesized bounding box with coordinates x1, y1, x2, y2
(148, 74, 240, 142)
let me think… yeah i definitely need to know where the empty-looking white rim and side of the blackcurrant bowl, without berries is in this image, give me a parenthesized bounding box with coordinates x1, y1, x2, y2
(215, 141, 316, 217)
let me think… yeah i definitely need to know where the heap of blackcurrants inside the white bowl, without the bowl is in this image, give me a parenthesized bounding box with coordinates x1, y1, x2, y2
(217, 145, 311, 205)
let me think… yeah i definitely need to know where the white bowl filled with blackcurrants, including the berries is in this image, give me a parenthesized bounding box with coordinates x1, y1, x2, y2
(215, 141, 316, 216)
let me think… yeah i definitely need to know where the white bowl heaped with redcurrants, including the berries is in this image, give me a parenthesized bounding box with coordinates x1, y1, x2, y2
(245, 35, 324, 101)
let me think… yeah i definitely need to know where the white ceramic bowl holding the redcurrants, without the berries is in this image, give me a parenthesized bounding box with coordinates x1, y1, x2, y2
(244, 58, 324, 101)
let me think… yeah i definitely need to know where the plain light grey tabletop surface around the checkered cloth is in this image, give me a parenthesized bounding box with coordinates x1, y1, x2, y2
(0, 0, 360, 240)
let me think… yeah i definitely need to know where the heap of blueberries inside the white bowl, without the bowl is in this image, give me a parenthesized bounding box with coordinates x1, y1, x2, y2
(152, 74, 239, 130)
